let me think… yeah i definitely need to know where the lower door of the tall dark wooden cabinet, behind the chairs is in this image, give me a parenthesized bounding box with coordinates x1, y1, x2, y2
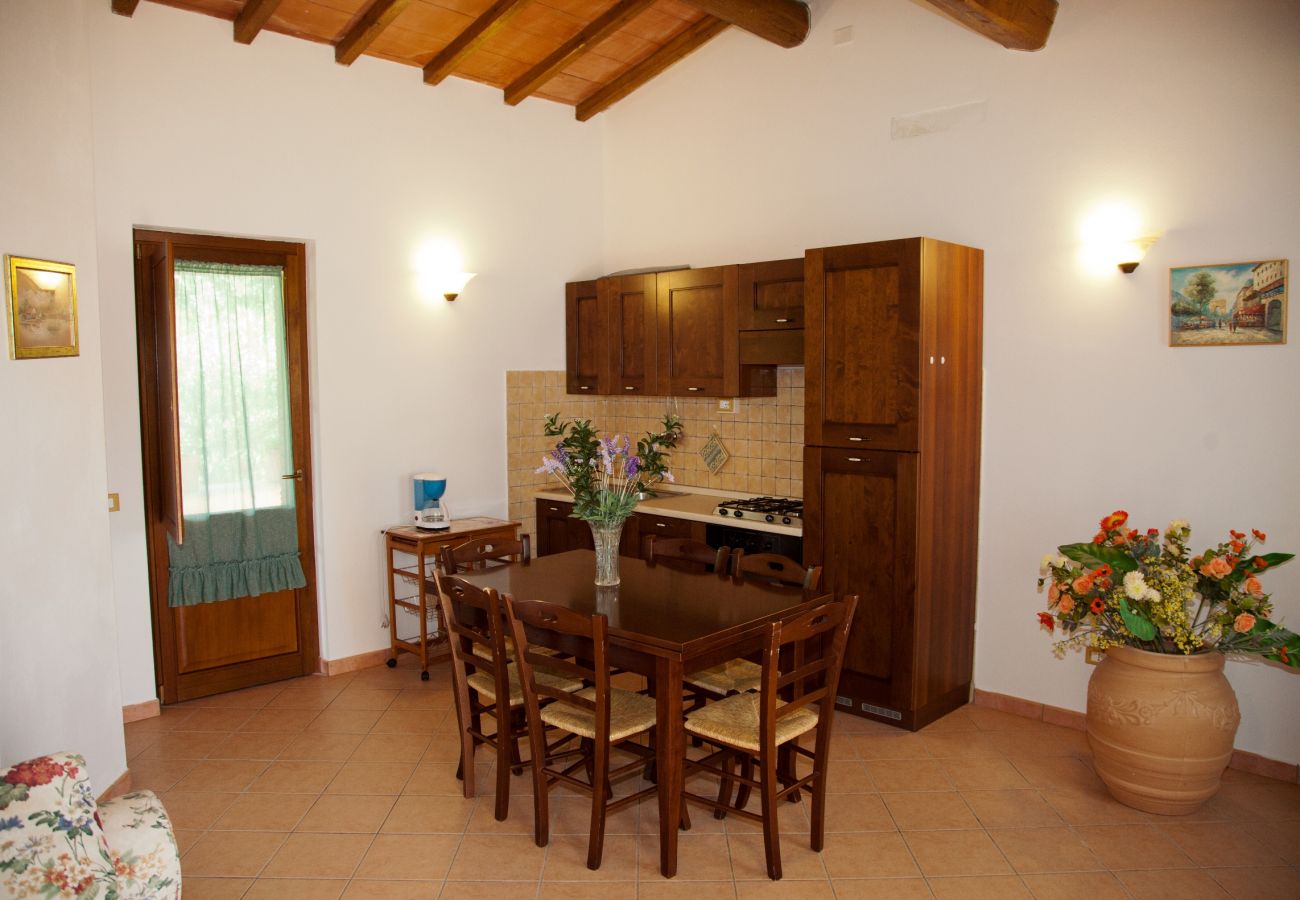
(803, 447, 918, 727)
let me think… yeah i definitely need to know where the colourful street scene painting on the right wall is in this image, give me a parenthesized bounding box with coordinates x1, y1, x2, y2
(1169, 259, 1287, 347)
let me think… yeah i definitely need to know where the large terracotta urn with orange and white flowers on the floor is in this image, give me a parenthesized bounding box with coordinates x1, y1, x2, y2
(1039, 510, 1300, 815)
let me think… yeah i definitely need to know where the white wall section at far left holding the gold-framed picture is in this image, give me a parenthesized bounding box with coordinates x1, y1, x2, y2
(0, 0, 126, 791)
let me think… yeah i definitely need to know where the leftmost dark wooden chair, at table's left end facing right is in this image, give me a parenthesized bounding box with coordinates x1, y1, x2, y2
(437, 572, 582, 822)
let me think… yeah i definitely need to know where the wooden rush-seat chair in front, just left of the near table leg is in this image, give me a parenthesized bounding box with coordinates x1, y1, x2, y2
(504, 594, 657, 869)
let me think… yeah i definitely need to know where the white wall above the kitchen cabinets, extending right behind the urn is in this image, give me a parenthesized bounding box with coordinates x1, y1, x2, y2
(605, 0, 1300, 762)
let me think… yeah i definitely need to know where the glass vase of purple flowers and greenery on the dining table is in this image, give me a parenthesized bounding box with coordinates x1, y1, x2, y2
(537, 412, 683, 585)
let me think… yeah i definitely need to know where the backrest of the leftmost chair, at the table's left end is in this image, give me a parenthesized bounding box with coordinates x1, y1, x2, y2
(434, 572, 510, 697)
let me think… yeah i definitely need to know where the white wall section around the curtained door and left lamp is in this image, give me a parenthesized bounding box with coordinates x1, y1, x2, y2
(85, 0, 601, 702)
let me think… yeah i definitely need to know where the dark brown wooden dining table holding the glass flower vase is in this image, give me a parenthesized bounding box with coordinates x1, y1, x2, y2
(444, 550, 828, 878)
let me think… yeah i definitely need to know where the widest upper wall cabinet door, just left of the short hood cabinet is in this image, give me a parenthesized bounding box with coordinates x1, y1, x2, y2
(657, 265, 740, 397)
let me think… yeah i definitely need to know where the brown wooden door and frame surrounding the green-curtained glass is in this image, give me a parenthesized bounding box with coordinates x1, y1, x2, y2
(134, 229, 320, 704)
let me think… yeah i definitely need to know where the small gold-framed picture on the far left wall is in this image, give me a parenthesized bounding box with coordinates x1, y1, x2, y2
(4, 255, 81, 359)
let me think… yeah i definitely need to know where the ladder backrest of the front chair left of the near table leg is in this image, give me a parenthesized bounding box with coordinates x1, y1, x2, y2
(504, 594, 610, 740)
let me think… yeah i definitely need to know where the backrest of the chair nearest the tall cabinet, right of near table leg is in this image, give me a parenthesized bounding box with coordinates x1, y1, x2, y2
(759, 594, 858, 743)
